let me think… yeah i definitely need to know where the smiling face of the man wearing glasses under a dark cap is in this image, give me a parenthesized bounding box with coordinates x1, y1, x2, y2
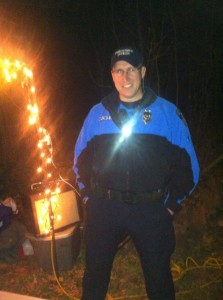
(111, 60, 146, 102)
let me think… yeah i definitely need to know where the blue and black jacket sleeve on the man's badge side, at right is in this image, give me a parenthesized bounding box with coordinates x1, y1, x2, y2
(166, 109, 200, 212)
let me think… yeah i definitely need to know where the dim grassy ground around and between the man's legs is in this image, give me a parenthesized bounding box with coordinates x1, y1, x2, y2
(0, 218, 223, 300)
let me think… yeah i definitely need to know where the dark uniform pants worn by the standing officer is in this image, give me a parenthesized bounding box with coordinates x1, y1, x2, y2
(82, 199, 175, 300)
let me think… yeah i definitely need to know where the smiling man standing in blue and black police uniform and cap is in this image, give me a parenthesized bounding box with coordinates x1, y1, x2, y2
(74, 47, 199, 300)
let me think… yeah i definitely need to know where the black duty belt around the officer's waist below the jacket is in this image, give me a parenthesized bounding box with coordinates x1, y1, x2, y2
(93, 187, 167, 204)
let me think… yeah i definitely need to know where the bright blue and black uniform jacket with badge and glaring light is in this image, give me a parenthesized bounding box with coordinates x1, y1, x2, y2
(74, 89, 199, 212)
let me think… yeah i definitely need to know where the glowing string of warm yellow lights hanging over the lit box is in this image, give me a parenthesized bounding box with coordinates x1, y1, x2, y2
(0, 58, 61, 234)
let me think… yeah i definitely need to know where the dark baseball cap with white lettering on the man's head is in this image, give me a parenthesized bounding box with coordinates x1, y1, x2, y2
(111, 47, 143, 69)
